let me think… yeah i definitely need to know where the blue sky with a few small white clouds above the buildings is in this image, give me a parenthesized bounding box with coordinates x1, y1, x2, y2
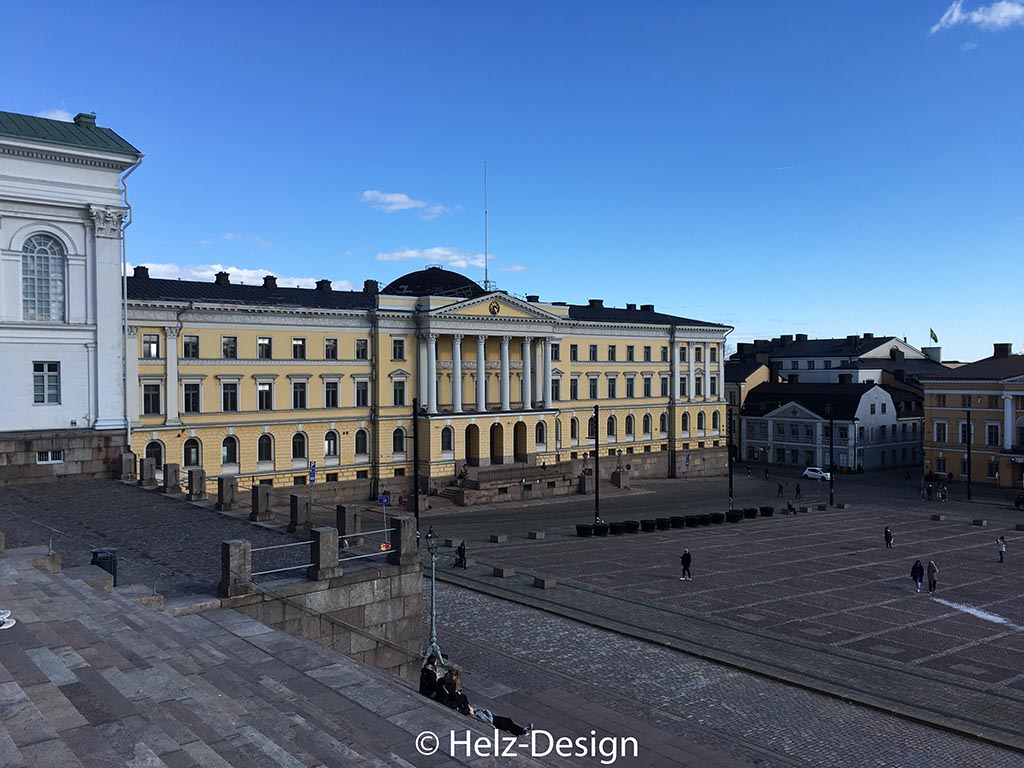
(0, 0, 1024, 359)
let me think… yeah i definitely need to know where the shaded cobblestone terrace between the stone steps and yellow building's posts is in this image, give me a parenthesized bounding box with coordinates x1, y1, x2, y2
(0, 480, 308, 597)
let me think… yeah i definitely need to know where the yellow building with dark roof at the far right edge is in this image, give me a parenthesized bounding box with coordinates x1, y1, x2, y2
(923, 344, 1024, 493)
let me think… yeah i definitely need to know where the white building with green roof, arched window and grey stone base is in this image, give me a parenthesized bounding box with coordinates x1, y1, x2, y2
(0, 113, 142, 482)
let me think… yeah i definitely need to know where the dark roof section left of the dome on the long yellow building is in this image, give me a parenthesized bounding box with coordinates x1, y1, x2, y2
(128, 278, 377, 309)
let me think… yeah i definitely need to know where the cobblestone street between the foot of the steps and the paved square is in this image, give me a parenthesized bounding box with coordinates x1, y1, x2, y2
(428, 584, 1022, 768)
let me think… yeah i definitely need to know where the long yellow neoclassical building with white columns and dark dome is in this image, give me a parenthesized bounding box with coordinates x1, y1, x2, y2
(127, 267, 732, 498)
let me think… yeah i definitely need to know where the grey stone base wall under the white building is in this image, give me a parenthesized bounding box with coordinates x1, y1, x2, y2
(0, 429, 125, 485)
